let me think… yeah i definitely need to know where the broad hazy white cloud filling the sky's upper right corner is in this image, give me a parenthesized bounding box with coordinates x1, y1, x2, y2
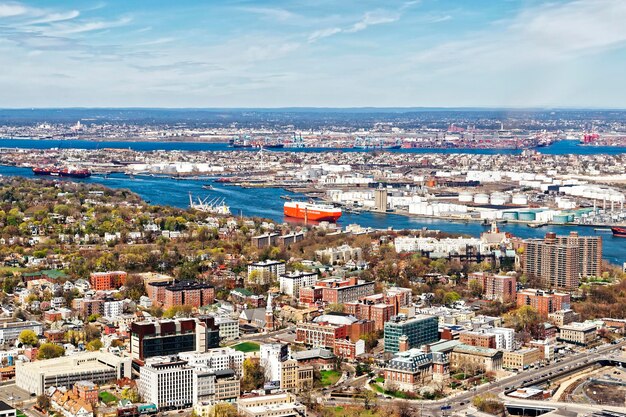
(413, 0, 626, 71)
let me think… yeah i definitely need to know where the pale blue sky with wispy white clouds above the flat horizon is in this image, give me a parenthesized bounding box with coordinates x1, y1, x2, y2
(0, 0, 626, 108)
